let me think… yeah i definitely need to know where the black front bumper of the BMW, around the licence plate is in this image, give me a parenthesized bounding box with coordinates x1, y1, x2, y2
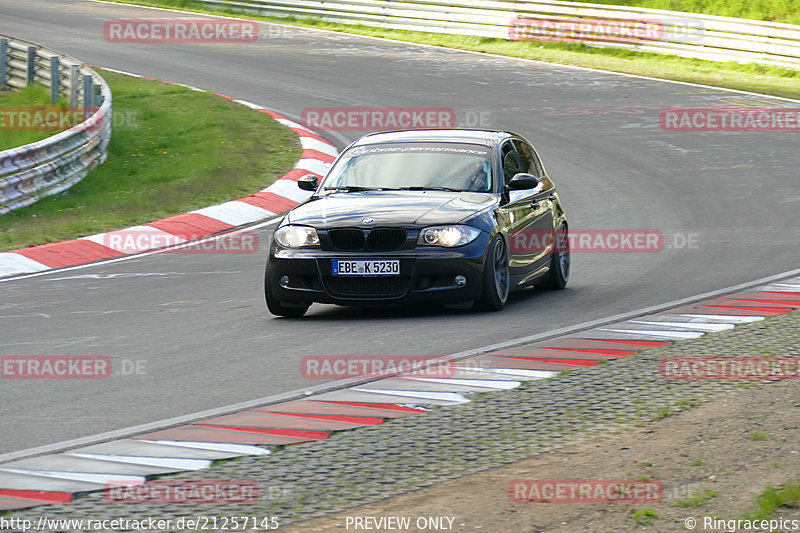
(265, 234, 489, 305)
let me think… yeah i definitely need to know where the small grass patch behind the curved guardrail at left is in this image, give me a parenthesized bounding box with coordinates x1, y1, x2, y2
(0, 84, 69, 150)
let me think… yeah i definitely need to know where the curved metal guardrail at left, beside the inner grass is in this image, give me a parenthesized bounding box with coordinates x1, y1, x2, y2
(0, 35, 112, 215)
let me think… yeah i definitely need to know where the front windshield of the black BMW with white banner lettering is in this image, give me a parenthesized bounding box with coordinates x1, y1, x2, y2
(323, 143, 492, 192)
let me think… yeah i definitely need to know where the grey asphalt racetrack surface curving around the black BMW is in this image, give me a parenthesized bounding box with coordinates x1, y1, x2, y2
(0, 0, 800, 453)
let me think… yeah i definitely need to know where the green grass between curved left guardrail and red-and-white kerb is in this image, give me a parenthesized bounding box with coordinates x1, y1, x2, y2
(0, 72, 300, 251)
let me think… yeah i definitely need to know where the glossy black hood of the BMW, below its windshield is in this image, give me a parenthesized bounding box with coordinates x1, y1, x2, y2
(287, 191, 497, 229)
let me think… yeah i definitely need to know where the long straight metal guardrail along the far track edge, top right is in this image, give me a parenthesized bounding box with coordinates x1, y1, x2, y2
(206, 0, 800, 69)
